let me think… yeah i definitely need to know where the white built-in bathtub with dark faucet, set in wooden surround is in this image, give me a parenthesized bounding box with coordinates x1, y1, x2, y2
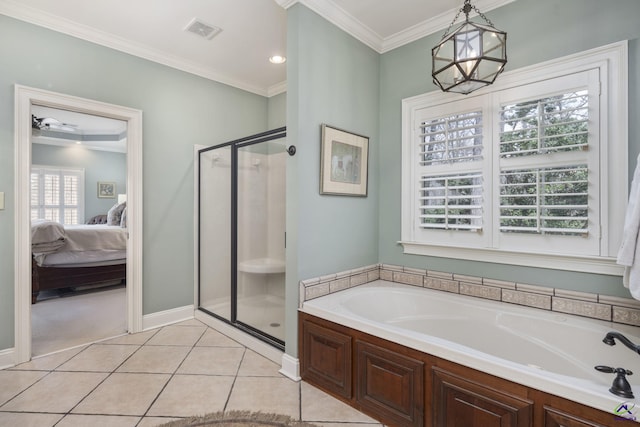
(301, 280, 640, 413)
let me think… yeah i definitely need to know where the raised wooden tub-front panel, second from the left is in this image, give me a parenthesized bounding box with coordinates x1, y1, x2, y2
(356, 341, 424, 426)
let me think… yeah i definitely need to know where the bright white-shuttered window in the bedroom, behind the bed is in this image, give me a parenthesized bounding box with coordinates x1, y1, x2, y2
(31, 166, 84, 225)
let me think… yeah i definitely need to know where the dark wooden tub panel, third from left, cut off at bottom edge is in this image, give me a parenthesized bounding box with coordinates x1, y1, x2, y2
(433, 367, 533, 427)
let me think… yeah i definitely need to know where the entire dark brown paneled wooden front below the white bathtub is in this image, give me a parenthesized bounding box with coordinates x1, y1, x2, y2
(299, 312, 620, 427)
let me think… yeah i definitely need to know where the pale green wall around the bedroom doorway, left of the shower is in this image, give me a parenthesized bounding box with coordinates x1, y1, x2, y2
(0, 15, 268, 350)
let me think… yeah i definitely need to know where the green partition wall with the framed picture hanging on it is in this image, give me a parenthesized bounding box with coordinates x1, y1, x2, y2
(286, 4, 380, 354)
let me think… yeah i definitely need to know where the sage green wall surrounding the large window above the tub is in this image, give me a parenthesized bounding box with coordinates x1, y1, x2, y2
(379, 0, 640, 297)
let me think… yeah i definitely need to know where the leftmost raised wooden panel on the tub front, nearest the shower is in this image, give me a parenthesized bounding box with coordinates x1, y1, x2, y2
(300, 319, 352, 399)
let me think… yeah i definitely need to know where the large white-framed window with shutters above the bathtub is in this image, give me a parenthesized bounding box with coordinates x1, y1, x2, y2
(402, 43, 628, 274)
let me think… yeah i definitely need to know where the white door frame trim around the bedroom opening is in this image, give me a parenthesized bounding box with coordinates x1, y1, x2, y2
(14, 84, 142, 364)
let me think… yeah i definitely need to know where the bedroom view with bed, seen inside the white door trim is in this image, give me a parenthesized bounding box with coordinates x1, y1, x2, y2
(30, 104, 127, 357)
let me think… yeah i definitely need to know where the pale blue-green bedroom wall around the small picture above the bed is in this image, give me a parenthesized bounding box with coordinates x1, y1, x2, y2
(31, 144, 127, 220)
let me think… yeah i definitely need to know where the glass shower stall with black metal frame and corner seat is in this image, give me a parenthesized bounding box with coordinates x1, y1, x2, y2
(198, 128, 288, 349)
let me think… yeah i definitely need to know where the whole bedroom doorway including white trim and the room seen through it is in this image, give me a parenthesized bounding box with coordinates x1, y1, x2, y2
(14, 85, 142, 364)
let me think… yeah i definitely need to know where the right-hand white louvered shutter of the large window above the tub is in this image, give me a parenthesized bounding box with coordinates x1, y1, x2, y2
(499, 89, 589, 235)
